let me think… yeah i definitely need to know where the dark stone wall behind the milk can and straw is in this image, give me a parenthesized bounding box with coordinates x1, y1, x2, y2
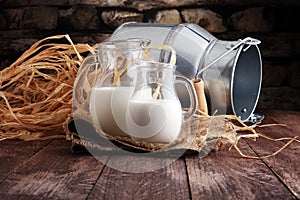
(0, 0, 300, 110)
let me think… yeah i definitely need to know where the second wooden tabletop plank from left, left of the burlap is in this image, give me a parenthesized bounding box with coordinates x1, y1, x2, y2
(0, 140, 109, 199)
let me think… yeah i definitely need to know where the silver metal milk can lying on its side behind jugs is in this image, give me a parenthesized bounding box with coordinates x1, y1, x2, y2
(110, 22, 262, 121)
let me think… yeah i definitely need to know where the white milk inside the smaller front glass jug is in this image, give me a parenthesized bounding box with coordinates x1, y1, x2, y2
(126, 99, 182, 143)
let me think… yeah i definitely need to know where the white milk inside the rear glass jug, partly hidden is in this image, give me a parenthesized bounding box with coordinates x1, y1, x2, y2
(90, 87, 133, 136)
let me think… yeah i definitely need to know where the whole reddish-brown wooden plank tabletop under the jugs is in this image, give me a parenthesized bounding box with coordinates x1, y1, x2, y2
(0, 111, 300, 200)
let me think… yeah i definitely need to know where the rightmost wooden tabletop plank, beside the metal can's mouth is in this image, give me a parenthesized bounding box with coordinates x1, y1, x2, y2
(247, 111, 300, 198)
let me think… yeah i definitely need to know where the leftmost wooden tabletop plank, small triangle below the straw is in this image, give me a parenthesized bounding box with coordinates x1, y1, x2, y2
(0, 140, 50, 182)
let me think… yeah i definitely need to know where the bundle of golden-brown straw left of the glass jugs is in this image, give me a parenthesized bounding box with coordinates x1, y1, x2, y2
(0, 35, 94, 140)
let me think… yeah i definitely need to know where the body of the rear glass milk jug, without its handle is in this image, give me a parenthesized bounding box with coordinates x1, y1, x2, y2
(86, 39, 150, 136)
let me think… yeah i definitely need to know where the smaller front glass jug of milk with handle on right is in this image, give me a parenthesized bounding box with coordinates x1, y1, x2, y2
(125, 60, 197, 143)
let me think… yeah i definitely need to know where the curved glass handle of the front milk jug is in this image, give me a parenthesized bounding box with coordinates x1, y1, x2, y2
(176, 75, 198, 121)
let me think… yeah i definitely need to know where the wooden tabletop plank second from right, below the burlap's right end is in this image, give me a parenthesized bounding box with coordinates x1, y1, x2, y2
(186, 141, 294, 199)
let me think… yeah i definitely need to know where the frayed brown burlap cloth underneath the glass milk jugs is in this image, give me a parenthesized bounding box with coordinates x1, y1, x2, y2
(64, 112, 237, 155)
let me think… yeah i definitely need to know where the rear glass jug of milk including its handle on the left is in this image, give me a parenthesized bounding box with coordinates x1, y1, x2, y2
(73, 39, 150, 135)
